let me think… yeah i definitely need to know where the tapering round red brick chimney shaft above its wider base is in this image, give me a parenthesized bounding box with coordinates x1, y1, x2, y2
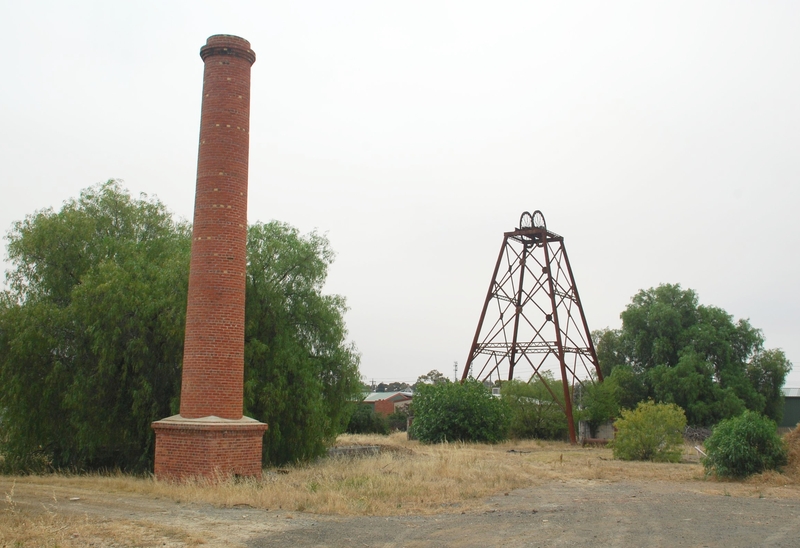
(180, 35, 255, 419)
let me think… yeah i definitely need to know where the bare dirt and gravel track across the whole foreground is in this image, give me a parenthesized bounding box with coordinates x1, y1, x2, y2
(0, 477, 800, 548)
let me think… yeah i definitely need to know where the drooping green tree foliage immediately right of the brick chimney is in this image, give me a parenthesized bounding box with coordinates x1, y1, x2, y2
(245, 221, 361, 464)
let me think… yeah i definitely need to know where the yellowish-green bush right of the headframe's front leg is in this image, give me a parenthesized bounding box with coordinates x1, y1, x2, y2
(611, 401, 686, 462)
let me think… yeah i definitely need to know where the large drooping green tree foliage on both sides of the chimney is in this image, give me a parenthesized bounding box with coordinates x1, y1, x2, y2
(0, 181, 359, 470)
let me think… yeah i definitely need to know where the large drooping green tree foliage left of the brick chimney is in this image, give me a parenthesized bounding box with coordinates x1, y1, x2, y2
(0, 181, 191, 469)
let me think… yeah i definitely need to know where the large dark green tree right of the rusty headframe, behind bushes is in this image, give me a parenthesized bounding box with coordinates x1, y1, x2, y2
(594, 284, 792, 425)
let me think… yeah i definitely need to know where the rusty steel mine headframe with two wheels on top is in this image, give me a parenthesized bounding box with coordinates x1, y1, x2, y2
(461, 210, 603, 443)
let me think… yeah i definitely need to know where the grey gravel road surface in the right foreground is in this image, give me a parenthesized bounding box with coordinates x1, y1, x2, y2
(248, 482, 800, 548)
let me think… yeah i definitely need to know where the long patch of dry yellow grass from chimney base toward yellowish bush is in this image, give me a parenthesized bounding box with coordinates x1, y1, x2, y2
(3, 433, 703, 516)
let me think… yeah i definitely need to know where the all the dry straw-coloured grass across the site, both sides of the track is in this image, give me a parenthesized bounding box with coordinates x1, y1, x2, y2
(0, 432, 800, 547)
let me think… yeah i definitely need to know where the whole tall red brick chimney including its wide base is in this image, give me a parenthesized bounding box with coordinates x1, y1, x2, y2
(153, 34, 267, 479)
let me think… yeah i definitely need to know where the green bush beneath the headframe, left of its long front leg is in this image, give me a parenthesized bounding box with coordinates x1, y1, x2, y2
(500, 376, 568, 440)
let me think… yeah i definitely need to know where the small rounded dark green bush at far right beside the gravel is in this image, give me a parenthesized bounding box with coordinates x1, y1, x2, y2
(703, 411, 787, 478)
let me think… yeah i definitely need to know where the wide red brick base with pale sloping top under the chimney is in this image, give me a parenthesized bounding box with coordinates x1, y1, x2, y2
(152, 415, 267, 480)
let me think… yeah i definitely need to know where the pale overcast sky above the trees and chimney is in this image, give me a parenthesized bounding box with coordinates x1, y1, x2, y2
(0, 0, 800, 386)
